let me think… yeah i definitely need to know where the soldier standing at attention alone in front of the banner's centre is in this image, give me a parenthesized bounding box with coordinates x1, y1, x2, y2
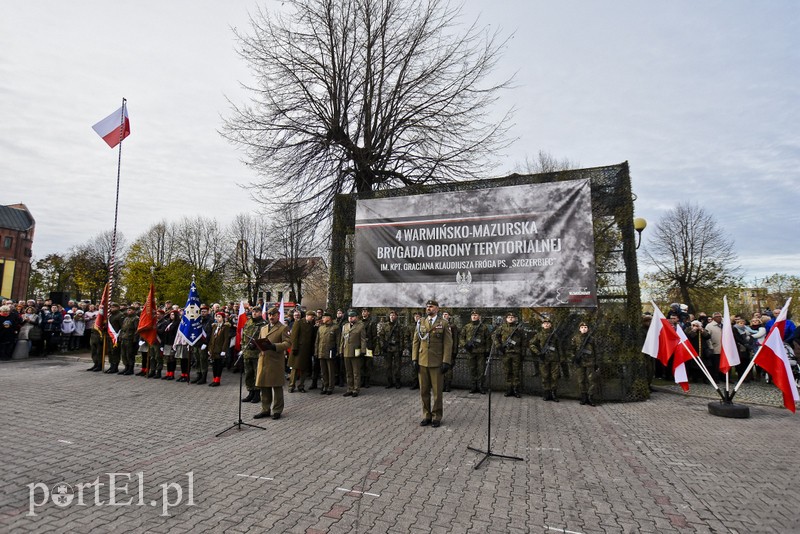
(411, 300, 453, 428)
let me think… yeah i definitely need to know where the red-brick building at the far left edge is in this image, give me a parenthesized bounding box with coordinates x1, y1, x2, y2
(0, 204, 36, 300)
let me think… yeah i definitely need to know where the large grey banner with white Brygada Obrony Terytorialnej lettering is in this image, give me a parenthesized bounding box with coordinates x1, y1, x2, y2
(353, 180, 597, 308)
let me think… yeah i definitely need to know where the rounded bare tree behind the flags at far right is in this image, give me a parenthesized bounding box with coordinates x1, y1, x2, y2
(645, 203, 741, 311)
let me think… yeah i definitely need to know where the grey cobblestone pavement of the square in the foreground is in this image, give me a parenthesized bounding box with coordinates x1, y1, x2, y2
(0, 359, 800, 534)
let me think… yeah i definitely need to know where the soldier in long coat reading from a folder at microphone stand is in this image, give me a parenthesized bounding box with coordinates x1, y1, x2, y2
(253, 307, 292, 419)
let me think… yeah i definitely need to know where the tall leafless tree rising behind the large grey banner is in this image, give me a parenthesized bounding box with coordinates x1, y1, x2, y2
(222, 0, 510, 220)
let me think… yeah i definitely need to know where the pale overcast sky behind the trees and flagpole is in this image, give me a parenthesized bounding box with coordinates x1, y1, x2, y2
(0, 0, 800, 280)
